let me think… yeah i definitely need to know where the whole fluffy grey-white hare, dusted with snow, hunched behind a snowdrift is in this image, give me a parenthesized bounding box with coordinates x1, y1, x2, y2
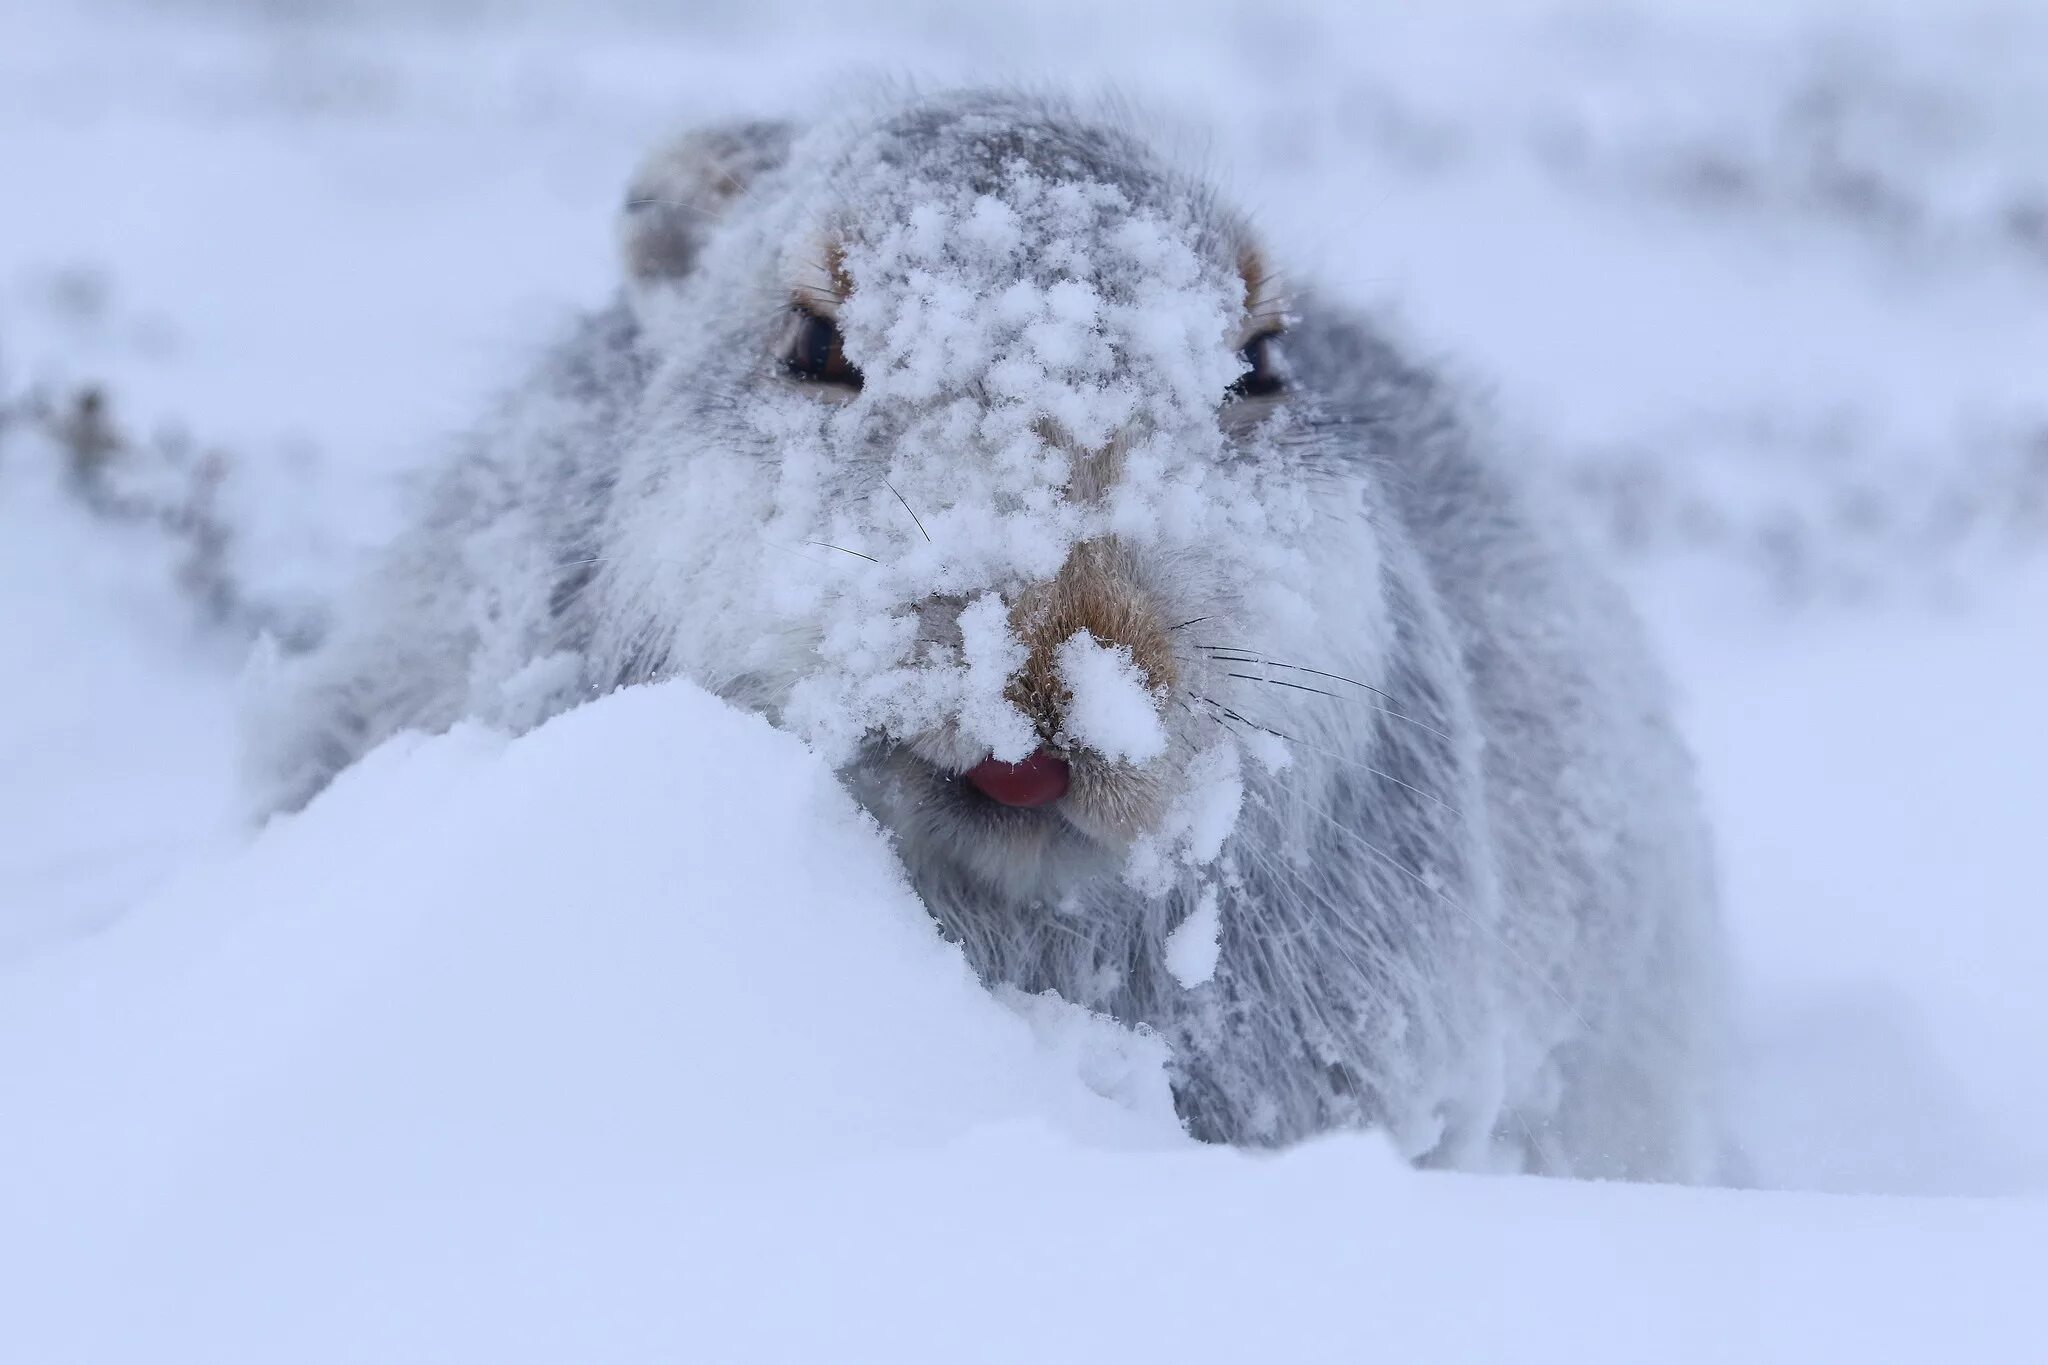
(252, 92, 1722, 1179)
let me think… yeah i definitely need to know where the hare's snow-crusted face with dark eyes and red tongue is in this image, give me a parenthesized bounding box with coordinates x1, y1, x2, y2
(606, 98, 1343, 894)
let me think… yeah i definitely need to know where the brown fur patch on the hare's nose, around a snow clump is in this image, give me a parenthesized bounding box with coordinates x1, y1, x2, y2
(1010, 540, 1178, 741)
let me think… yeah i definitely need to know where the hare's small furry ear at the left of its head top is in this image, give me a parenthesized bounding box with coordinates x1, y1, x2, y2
(618, 121, 793, 293)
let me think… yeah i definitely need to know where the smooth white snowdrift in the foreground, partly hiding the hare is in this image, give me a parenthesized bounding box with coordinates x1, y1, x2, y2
(0, 684, 2048, 1363)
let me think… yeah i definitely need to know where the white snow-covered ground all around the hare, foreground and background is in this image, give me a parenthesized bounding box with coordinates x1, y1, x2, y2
(0, 0, 2048, 1361)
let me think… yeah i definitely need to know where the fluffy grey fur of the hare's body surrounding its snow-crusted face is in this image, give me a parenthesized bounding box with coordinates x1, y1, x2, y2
(252, 94, 1722, 1179)
